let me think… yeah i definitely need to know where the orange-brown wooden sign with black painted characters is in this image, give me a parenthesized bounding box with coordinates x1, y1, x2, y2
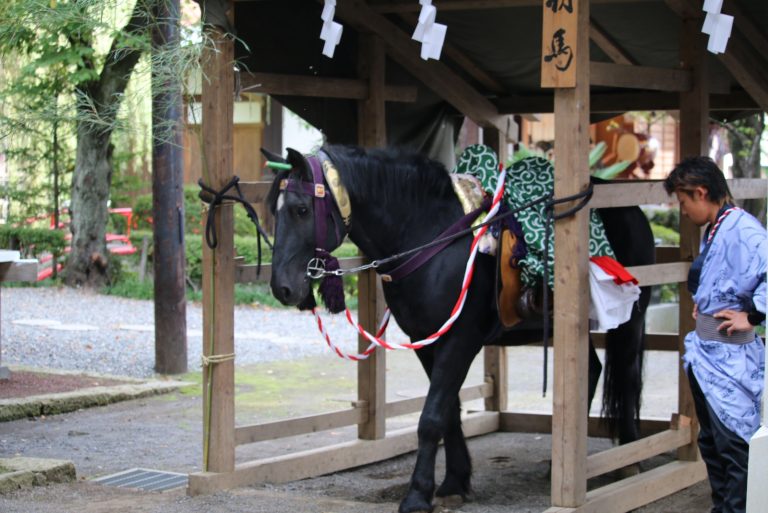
(541, 0, 579, 87)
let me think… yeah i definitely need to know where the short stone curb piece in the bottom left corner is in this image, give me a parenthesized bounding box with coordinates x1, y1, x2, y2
(0, 457, 77, 495)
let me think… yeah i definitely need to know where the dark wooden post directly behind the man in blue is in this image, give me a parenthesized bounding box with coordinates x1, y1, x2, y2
(677, 13, 709, 461)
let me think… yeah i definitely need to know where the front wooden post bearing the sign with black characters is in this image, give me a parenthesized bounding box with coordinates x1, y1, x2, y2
(542, 0, 589, 507)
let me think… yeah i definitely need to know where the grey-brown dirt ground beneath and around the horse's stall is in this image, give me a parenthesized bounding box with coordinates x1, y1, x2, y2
(0, 348, 709, 513)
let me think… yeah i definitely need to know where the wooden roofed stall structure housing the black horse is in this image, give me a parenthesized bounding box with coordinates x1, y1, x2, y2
(189, 0, 768, 513)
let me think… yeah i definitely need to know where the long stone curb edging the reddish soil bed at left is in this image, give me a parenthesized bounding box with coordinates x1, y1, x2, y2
(0, 381, 193, 422)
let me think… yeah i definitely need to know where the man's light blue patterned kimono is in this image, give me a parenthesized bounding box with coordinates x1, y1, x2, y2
(683, 210, 768, 442)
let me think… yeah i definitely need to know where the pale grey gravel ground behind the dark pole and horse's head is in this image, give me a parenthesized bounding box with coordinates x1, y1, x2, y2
(0, 288, 414, 378)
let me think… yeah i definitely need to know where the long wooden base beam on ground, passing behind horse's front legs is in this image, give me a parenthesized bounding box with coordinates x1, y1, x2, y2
(187, 412, 499, 495)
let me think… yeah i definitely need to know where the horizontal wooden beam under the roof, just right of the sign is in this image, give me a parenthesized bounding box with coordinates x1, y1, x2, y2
(589, 62, 691, 92)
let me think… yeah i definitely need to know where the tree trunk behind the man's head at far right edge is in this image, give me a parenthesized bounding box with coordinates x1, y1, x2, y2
(727, 112, 766, 224)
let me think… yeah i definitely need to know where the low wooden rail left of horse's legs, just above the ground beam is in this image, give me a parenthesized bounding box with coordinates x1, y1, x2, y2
(235, 405, 368, 445)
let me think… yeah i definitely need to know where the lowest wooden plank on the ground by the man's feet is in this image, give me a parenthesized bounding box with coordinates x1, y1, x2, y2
(544, 461, 707, 513)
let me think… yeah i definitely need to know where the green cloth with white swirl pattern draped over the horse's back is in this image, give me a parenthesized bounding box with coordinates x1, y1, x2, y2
(453, 144, 616, 287)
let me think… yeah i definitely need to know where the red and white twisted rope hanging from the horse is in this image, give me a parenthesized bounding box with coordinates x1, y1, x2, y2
(312, 166, 506, 361)
